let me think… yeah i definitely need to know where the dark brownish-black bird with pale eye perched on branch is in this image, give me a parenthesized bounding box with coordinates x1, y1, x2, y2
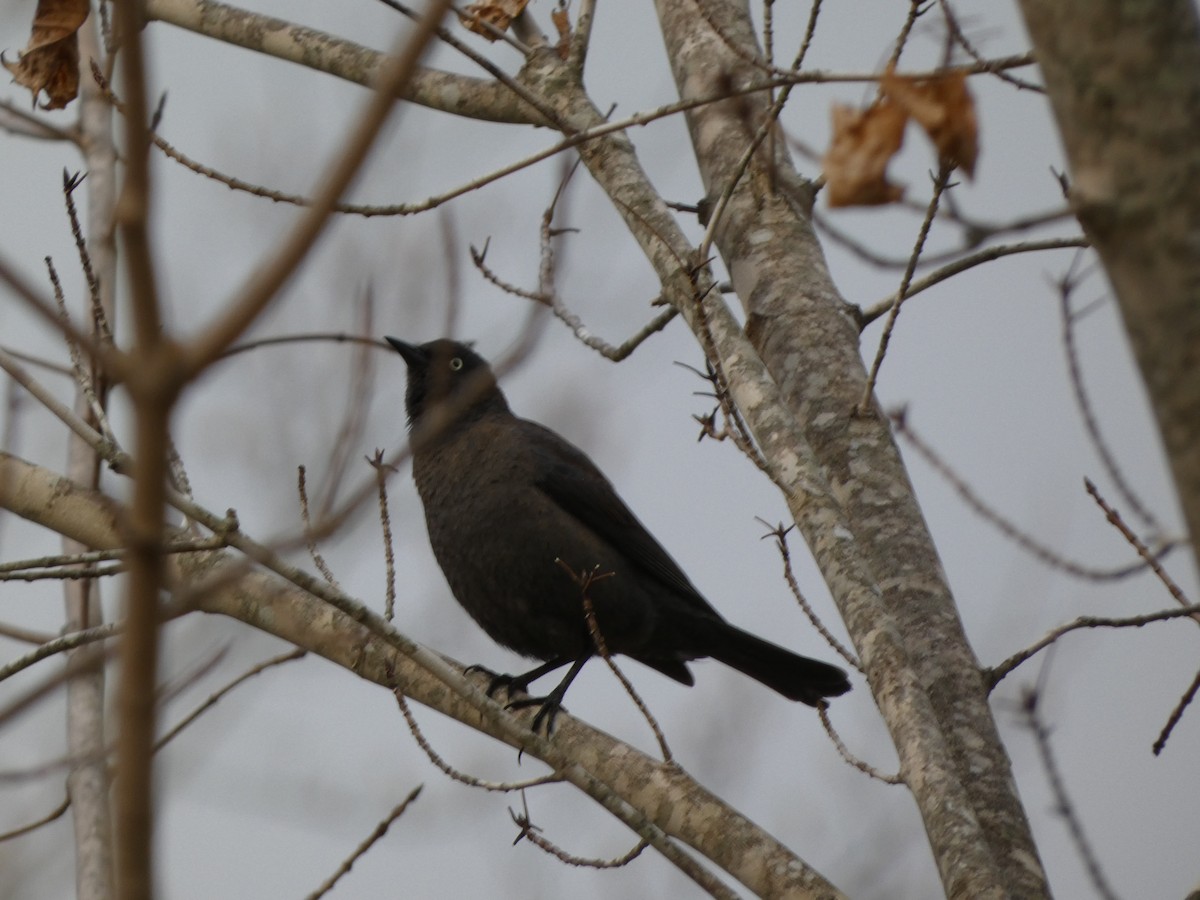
(388, 337, 850, 731)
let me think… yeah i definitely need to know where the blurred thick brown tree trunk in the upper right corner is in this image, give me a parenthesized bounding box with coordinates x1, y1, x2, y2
(1021, 0, 1200, 573)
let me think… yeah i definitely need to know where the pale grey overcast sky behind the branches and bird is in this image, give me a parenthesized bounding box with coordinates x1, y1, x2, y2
(0, 0, 1200, 900)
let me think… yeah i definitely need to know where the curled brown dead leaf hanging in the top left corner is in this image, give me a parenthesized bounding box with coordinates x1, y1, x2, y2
(0, 0, 88, 109)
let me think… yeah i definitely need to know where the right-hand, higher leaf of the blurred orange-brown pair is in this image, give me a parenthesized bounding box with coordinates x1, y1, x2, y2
(881, 68, 979, 176)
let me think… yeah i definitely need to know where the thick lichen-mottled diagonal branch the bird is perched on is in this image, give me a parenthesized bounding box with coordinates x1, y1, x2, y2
(0, 454, 840, 898)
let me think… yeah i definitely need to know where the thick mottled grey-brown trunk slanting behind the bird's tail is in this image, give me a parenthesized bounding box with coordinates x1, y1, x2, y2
(658, 0, 1048, 900)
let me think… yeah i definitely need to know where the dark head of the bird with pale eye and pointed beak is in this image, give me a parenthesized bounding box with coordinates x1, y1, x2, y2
(385, 337, 508, 428)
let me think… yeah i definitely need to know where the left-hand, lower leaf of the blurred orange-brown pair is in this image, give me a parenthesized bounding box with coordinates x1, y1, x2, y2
(822, 98, 908, 206)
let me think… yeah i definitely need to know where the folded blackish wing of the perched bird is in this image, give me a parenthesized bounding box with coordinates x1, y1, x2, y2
(522, 420, 720, 618)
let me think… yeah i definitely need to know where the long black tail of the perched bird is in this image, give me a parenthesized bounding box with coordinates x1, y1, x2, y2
(702, 622, 850, 707)
